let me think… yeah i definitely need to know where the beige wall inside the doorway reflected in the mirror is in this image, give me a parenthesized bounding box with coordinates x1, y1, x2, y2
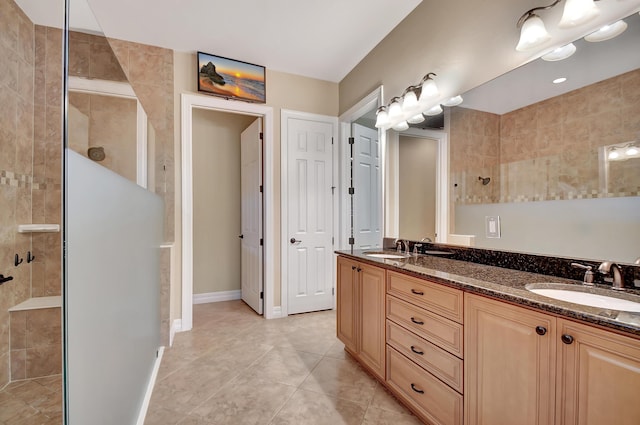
(398, 136, 438, 240)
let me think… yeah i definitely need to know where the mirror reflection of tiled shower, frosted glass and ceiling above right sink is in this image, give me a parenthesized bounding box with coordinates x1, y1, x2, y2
(450, 14, 640, 262)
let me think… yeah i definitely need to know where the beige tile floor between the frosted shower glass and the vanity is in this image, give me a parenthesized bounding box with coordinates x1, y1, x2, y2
(145, 301, 421, 425)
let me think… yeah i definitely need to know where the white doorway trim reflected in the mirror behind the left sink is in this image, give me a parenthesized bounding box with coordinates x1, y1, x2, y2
(392, 128, 449, 243)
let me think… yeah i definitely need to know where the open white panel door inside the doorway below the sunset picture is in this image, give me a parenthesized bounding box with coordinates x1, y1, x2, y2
(240, 118, 263, 314)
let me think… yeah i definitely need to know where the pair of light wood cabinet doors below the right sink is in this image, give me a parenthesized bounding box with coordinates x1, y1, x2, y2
(465, 294, 640, 425)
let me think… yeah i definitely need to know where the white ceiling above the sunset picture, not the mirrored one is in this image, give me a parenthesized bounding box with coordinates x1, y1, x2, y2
(16, 0, 422, 82)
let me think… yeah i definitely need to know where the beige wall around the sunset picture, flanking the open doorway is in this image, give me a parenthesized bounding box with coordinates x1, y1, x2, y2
(171, 52, 338, 320)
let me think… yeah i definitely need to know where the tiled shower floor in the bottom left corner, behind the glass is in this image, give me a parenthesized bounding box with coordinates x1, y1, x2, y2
(0, 375, 62, 425)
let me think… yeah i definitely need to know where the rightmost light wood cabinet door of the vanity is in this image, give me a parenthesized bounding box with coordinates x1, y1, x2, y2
(556, 319, 640, 425)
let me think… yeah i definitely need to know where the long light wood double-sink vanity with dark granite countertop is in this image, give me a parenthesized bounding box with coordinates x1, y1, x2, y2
(337, 244, 640, 425)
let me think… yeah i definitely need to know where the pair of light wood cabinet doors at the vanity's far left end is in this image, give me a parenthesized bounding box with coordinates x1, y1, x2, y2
(337, 257, 385, 380)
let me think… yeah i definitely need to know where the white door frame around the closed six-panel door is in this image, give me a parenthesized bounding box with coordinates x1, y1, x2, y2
(280, 109, 339, 316)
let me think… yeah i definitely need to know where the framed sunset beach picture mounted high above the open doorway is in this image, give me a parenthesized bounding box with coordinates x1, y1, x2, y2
(198, 52, 266, 103)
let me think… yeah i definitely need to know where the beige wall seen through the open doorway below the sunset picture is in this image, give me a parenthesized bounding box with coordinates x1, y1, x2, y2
(193, 109, 256, 294)
